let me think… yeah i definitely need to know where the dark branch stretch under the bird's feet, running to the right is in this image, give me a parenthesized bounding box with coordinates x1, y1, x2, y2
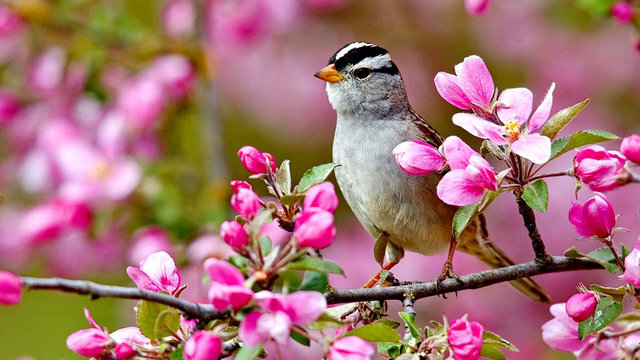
(325, 256, 602, 304)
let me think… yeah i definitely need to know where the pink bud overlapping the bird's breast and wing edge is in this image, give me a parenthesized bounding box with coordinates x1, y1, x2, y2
(392, 140, 445, 176)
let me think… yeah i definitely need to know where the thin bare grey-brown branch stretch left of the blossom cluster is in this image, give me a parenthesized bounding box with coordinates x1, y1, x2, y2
(21, 276, 229, 322)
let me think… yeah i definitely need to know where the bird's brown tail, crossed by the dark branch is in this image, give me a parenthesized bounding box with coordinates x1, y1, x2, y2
(457, 214, 550, 303)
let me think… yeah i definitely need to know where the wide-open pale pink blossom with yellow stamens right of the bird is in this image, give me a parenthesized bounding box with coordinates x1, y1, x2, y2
(453, 84, 555, 164)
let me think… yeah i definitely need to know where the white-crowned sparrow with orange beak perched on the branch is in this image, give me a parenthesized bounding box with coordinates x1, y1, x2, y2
(314, 41, 549, 303)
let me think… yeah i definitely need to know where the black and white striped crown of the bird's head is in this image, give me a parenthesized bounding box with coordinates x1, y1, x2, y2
(329, 42, 400, 75)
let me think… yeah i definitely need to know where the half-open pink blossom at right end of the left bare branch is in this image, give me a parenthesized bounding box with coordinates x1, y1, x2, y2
(204, 259, 253, 311)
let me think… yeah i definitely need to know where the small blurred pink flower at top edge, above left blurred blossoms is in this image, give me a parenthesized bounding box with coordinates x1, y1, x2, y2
(162, 0, 197, 39)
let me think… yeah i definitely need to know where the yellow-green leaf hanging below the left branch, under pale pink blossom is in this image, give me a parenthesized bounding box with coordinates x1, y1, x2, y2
(136, 300, 180, 339)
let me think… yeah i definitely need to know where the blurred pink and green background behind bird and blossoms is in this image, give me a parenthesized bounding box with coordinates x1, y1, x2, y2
(0, 0, 640, 359)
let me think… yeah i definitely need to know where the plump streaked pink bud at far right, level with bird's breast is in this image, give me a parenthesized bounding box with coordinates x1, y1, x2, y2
(573, 145, 627, 191)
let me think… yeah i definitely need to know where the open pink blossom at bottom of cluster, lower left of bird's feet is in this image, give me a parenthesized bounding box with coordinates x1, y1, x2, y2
(239, 290, 327, 347)
